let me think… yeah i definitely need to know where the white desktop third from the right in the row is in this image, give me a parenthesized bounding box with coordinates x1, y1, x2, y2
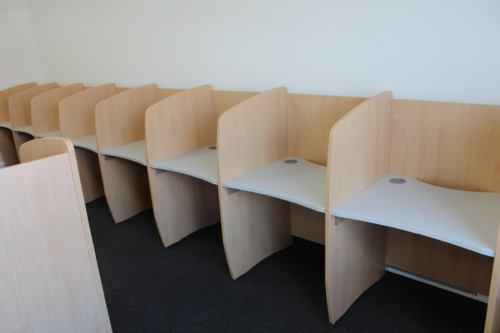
(150, 145, 218, 185)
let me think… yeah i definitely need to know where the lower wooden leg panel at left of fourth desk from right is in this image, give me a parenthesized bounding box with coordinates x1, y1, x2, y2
(99, 154, 152, 223)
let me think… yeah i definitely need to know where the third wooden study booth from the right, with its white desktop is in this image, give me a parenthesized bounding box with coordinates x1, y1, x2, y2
(146, 85, 257, 246)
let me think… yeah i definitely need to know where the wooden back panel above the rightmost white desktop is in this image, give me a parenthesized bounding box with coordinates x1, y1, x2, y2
(390, 100, 500, 193)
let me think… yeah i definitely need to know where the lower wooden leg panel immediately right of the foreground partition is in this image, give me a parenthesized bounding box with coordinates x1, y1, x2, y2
(75, 147, 104, 203)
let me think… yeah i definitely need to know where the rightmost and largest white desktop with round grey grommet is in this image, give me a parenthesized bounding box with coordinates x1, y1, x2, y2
(330, 175, 500, 257)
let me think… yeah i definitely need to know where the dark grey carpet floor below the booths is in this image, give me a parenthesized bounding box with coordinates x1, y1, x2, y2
(87, 198, 486, 333)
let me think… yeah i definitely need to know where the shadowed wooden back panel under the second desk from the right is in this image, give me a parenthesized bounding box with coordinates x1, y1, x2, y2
(290, 203, 325, 245)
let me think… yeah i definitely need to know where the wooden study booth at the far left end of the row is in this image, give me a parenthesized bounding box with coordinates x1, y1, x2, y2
(0, 82, 37, 166)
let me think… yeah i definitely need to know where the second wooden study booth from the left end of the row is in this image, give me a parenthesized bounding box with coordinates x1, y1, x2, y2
(9, 83, 59, 155)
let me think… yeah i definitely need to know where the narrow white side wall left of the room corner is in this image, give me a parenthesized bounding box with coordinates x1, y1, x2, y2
(0, 0, 42, 167)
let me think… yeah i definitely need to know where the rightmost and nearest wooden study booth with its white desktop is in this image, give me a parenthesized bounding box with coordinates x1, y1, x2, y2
(326, 92, 500, 332)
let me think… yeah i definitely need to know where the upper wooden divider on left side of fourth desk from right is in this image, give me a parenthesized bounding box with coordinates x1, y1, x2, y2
(95, 84, 158, 151)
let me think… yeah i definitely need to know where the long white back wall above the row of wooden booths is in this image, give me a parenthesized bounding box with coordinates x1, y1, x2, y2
(28, 0, 500, 104)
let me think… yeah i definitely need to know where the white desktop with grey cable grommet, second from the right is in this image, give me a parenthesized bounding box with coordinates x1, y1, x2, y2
(222, 157, 326, 213)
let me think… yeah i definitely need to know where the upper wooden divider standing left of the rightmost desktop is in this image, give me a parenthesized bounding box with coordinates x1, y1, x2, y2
(326, 91, 392, 212)
